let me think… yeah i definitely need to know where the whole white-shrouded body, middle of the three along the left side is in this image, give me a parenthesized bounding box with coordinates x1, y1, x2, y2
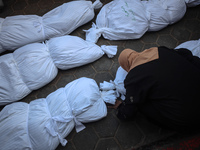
(0, 35, 117, 105)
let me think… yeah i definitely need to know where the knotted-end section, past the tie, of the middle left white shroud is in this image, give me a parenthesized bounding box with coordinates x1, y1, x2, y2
(46, 35, 117, 70)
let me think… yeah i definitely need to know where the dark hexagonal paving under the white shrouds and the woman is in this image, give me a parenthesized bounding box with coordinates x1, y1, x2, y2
(0, 0, 200, 150)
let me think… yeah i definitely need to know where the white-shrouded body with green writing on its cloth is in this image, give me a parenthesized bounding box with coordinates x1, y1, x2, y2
(85, 0, 186, 43)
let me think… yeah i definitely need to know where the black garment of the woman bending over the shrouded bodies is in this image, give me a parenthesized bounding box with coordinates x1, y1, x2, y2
(117, 47, 200, 129)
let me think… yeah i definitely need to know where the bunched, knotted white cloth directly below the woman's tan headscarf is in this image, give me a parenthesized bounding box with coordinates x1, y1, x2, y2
(100, 66, 128, 104)
